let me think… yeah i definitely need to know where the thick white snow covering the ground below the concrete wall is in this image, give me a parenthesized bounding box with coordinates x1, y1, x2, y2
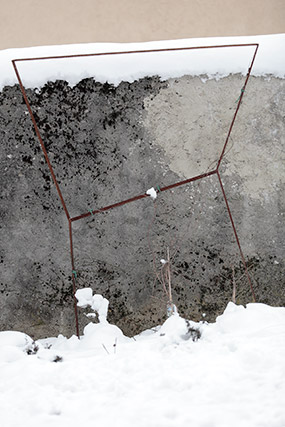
(0, 303, 285, 427)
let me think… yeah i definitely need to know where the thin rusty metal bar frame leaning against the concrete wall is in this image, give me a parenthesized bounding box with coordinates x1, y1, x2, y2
(12, 43, 259, 337)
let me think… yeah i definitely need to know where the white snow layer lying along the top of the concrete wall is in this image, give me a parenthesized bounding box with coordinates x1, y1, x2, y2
(0, 34, 285, 90)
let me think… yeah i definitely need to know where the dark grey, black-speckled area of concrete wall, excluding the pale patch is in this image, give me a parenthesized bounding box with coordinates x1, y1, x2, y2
(0, 77, 285, 338)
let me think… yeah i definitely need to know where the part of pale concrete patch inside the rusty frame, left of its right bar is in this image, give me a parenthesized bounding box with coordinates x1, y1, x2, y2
(144, 76, 244, 178)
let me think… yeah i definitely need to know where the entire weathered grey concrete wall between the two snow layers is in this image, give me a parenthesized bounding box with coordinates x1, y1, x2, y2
(0, 75, 285, 337)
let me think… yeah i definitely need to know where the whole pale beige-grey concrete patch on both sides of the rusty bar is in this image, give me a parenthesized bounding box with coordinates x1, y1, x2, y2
(144, 75, 285, 203)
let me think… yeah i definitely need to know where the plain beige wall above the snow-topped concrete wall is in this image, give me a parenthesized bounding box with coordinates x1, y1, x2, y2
(0, 0, 285, 49)
